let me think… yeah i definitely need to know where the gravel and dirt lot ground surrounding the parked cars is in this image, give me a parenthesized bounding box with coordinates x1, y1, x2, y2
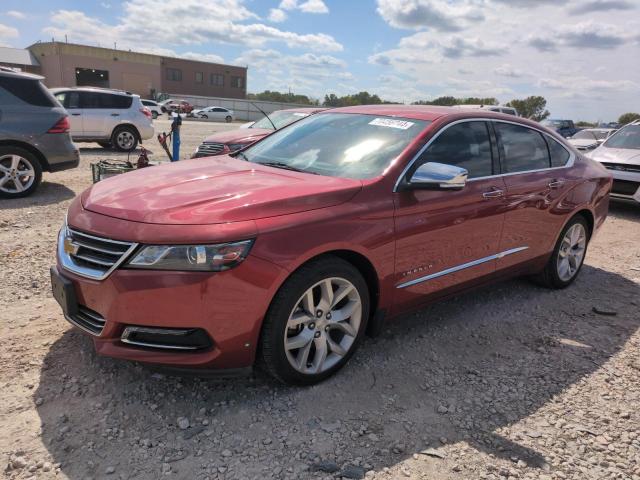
(0, 120, 640, 480)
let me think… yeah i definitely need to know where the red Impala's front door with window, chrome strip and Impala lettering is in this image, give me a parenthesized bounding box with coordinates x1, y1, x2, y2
(395, 120, 506, 310)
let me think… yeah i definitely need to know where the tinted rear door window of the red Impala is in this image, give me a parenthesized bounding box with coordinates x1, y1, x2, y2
(494, 122, 550, 173)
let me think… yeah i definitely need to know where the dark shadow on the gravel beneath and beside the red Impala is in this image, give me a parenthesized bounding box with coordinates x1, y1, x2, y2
(34, 266, 640, 479)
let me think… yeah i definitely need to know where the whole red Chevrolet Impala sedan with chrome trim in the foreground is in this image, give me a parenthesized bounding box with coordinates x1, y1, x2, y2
(51, 105, 612, 384)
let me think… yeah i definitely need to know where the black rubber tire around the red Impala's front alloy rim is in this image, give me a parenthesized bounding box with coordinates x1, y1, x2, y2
(258, 255, 370, 385)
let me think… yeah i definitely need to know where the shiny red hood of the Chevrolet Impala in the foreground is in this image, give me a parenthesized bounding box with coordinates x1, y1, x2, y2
(82, 155, 362, 225)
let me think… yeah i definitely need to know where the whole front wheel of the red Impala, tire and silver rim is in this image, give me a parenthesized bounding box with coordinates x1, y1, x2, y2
(260, 256, 369, 385)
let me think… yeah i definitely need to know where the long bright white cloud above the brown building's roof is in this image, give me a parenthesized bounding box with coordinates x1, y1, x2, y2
(43, 0, 343, 51)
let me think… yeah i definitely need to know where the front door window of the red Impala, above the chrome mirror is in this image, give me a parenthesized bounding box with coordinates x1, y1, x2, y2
(416, 122, 493, 178)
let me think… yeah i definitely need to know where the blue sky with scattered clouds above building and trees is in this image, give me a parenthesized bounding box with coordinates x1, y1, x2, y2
(0, 0, 640, 121)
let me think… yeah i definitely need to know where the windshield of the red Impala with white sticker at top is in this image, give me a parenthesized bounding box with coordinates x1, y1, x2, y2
(242, 113, 430, 179)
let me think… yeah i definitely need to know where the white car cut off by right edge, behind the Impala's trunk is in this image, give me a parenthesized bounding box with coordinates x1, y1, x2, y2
(586, 120, 640, 204)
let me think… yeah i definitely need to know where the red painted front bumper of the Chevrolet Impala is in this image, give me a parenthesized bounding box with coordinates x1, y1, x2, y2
(57, 256, 283, 370)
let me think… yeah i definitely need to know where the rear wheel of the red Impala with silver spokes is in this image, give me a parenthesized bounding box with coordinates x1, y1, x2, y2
(534, 215, 589, 288)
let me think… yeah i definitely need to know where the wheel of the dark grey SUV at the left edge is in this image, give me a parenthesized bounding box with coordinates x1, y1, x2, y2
(0, 147, 42, 198)
